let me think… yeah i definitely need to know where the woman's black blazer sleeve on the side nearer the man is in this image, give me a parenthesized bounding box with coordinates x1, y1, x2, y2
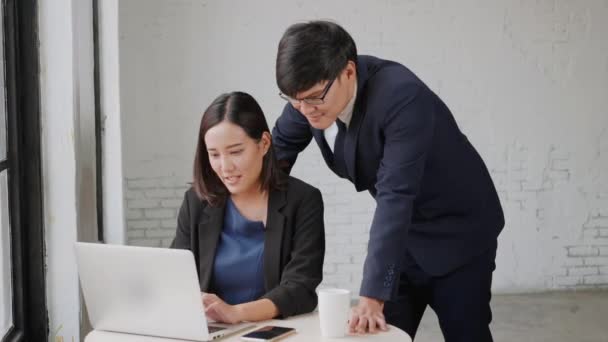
(263, 189, 325, 318)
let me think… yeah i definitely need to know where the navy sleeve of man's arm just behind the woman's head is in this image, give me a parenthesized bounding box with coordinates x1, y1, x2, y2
(272, 104, 312, 174)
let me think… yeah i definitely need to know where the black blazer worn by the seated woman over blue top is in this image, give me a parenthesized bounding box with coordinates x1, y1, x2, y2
(171, 177, 325, 317)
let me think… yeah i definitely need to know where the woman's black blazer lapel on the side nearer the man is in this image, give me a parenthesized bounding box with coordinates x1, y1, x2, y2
(264, 190, 287, 290)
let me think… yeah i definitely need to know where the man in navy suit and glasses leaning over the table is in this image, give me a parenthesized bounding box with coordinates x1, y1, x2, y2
(273, 21, 504, 342)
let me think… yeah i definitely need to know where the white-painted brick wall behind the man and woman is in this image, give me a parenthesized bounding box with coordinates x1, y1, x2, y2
(120, 0, 608, 292)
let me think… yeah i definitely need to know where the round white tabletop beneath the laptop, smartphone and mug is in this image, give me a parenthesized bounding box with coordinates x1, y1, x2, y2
(85, 312, 412, 342)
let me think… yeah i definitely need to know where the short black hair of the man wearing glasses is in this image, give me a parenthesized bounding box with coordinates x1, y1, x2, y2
(276, 20, 357, 97)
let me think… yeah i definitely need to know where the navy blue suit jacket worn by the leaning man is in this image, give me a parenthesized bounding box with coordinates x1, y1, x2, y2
(273, 56, 504, 300)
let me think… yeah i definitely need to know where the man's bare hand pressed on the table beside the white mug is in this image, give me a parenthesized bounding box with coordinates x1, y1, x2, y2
(348, 297, 388, 334)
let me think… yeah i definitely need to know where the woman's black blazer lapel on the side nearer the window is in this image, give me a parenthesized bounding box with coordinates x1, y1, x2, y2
(198, 202, 226, 291)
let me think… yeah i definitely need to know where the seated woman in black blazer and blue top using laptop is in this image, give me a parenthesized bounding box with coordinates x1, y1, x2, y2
(171, 92, 325, 323)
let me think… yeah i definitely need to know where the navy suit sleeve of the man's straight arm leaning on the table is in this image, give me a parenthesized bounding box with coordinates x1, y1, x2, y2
(360, 88, 435, 301)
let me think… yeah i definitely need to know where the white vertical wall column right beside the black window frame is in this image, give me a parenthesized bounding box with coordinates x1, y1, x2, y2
(38, 0, 80, 341)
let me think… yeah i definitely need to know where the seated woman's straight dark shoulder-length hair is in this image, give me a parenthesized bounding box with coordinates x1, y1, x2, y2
(193, 91, 285, 206)
